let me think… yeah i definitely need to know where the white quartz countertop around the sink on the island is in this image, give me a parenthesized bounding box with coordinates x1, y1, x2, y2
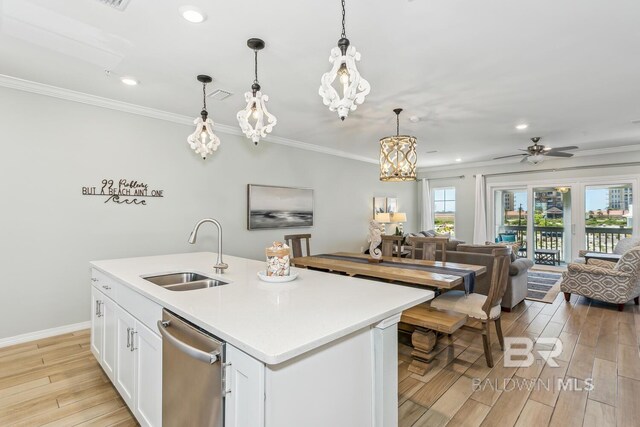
(91, 252, 434, 365)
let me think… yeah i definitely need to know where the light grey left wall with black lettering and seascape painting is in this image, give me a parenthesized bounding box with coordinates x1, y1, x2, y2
(0, 88, 417, 339)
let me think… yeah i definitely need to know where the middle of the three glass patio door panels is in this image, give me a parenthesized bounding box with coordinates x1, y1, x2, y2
(528, 186, 574, 266)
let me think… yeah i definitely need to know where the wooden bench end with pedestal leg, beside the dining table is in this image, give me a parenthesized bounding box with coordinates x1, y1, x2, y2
(400, 303, 467, 375)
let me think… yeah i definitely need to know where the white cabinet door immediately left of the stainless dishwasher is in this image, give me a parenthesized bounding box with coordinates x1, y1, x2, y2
(134, 322, 162, 426)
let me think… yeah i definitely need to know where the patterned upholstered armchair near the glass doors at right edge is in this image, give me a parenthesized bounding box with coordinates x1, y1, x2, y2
(560, 247, 640, 311)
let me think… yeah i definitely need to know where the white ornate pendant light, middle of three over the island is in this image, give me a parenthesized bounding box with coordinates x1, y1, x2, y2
(236, 39, 277, 145)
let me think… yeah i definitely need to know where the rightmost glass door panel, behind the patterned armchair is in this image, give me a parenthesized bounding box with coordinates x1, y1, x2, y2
(581, 183, 633, 253)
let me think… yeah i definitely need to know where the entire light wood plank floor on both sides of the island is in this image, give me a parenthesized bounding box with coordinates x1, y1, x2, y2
(0, 294, 640, 427)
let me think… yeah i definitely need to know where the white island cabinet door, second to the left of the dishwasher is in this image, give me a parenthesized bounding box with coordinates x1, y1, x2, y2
(115, 306, 136, 408)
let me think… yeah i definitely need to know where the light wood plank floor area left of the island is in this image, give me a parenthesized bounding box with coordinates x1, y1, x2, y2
(0, 330, 137, 426)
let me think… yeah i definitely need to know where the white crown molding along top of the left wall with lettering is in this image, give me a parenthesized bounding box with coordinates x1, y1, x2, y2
(0, 74, 378, 164)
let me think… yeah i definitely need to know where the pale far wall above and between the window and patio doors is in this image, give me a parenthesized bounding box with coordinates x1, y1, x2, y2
(418, 152, 640, 246)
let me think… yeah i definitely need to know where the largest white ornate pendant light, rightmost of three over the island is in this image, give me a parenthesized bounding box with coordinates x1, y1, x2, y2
(318, 0, 371, 120)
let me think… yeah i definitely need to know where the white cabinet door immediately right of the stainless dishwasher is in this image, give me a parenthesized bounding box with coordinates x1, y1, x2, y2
(224, 343, 265, 427)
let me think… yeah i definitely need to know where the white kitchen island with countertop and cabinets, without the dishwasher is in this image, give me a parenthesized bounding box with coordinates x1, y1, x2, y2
(91, 252, 434, 427)
